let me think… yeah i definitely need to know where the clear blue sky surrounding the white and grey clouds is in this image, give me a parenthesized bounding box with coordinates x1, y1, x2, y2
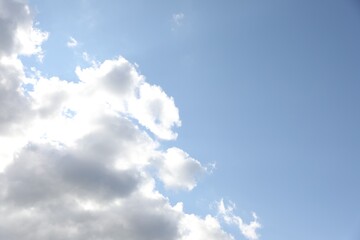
(0, 0, 360, 240)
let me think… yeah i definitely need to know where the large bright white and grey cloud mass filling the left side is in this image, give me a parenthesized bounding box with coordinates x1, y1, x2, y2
(0, 0, 259, 240)
